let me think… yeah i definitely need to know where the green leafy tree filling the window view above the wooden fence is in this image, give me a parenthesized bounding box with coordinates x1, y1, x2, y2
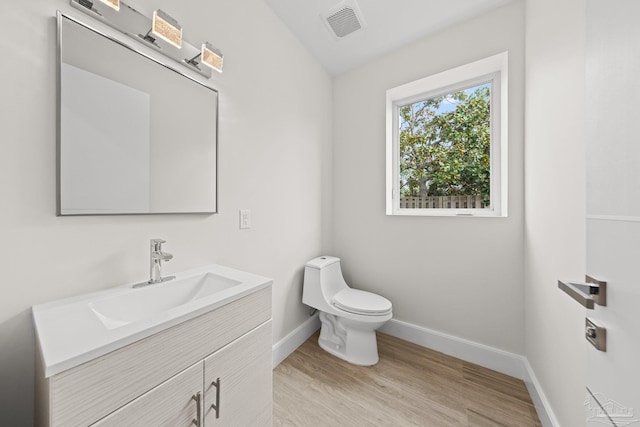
(399, 84, 491, 197)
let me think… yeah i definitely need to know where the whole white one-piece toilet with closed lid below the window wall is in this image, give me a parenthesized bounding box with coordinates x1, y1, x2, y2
(302, 256, 392, 366)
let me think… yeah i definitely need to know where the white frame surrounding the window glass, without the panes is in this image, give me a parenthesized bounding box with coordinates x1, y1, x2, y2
(386, 52, 509, 217)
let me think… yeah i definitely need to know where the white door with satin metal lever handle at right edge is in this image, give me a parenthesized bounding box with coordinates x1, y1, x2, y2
(585, 0, 640, 426)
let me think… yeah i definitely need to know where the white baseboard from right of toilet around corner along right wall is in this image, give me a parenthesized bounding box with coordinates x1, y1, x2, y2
(379, 319, 560, 427)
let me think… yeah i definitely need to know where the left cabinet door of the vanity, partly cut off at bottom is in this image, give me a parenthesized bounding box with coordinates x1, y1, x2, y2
(93, 362, 204, 427)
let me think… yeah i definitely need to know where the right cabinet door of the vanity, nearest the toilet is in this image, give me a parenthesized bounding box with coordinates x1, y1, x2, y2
(204, 321, 272, 427)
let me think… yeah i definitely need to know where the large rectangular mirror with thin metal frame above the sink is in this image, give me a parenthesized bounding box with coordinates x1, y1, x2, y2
(57, 13, 218, 215)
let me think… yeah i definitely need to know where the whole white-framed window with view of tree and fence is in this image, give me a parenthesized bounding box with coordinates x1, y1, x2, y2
(387, 52, 508, 216)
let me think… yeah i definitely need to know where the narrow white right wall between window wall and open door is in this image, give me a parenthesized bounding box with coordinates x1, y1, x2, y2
(525, 0, 586, 426)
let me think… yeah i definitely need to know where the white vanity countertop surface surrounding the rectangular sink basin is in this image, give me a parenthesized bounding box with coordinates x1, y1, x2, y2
(32, 265, 273, 377)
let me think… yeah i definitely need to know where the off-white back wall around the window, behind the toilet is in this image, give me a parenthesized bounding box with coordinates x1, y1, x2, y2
(333, 1, 524, 354)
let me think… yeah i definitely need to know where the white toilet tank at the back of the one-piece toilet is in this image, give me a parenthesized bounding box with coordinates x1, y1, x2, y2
(302, 256, 348, 310)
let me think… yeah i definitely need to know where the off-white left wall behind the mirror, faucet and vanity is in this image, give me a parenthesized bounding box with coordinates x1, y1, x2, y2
(0, 0, 332, 427)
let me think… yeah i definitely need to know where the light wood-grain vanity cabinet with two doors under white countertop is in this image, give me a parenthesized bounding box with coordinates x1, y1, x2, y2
(36, 287, 272, 427)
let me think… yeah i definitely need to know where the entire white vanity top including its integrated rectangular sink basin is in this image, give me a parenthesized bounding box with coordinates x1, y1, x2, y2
(32, 265, 273, 377)
